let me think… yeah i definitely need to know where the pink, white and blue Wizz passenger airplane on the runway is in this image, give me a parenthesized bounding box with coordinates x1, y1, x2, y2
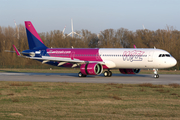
(13, 21, 177, 78)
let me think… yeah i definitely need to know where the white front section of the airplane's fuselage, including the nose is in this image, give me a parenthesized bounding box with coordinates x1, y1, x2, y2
(99, 48, 177, 69)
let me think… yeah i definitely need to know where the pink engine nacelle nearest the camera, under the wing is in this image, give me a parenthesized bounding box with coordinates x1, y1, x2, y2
(80, 63, 103, 75)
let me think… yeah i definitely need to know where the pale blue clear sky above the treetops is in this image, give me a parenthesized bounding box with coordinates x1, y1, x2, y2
(0, 0, 180, 33)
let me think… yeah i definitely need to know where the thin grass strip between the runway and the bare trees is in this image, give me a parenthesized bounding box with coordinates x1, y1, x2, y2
(0, 68, 180, 74)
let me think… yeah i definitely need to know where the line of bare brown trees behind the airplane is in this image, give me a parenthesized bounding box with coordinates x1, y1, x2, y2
(0, 24, 180, 69)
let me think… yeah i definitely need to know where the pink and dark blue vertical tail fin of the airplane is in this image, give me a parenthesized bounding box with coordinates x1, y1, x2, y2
(25, 21, 47, 50)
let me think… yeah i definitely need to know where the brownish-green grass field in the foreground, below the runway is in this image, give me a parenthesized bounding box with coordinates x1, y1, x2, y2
(0, 82, 180, 120)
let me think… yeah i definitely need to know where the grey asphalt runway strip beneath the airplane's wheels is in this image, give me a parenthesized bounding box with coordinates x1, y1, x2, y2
(0, 73, 180, 84)
